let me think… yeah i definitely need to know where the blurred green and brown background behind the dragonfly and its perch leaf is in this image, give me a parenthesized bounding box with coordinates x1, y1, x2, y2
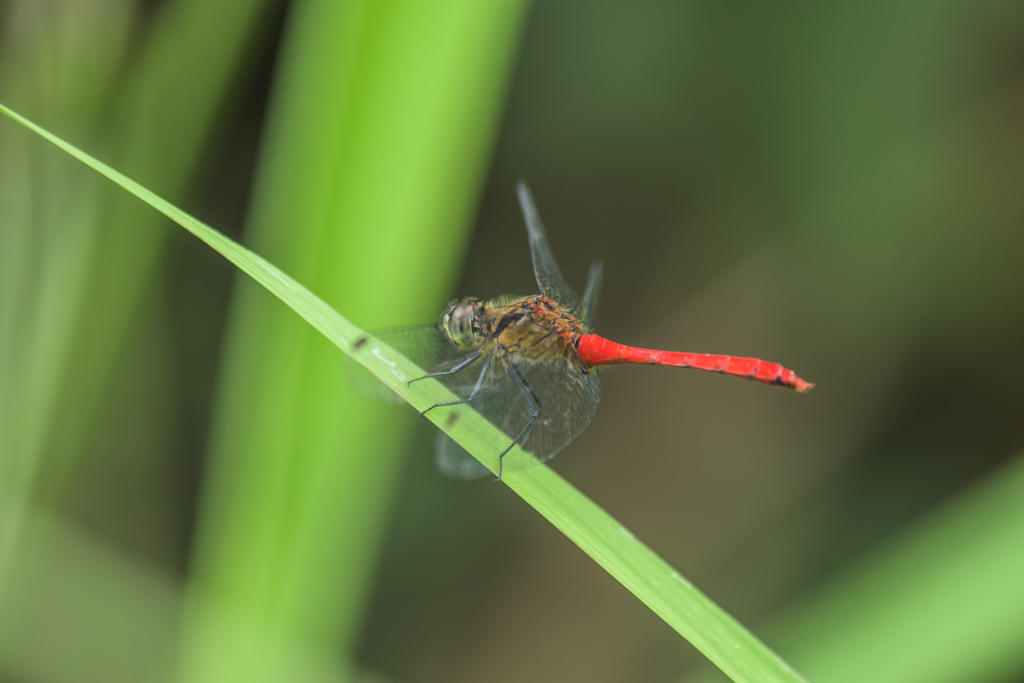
(0, 0, 1024, 683)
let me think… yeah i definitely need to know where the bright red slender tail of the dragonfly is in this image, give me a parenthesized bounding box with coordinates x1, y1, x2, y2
(577, 335, 814, 393)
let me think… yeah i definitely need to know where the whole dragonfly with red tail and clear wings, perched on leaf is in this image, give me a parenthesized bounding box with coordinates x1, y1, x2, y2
(346, 181, 814, 481)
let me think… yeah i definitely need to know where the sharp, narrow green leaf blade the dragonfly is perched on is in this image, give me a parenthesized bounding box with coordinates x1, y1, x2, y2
(0, 105, 804, 683)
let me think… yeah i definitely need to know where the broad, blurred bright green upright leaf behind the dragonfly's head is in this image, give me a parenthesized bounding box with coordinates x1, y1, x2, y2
(178, 0, 526, 683)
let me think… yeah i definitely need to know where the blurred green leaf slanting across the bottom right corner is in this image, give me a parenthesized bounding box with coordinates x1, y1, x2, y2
(687, 450, 1024, 683)
